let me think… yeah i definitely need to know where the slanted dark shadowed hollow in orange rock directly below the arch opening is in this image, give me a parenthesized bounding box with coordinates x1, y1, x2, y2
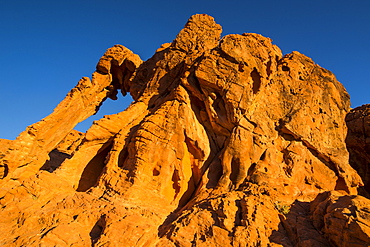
(77, 144, 112, 192)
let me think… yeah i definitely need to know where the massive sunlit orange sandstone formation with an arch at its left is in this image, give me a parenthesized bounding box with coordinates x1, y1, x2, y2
(0, 15, 370, 247)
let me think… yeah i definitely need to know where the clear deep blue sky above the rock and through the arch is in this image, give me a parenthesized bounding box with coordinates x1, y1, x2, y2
(0, 0, 370, 139)
